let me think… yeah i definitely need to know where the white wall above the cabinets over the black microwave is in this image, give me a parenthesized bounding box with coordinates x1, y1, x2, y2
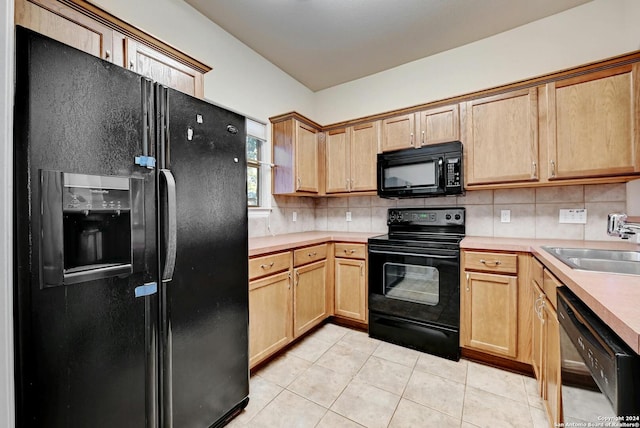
(311, 0, 640, 125)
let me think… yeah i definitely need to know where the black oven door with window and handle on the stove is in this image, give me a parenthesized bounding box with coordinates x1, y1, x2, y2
(369, 244, 460, 330)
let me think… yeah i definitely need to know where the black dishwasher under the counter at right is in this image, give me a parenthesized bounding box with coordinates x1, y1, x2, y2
(558, 287, 640, 426)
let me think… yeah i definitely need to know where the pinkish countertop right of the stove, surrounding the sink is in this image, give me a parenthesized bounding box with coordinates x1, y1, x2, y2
(460, 236, 640, 354)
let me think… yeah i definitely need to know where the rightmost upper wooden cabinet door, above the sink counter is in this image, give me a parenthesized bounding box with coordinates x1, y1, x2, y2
(547, 64, 640, 179)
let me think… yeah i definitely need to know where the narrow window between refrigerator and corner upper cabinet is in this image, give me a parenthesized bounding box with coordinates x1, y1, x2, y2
(247, 119, 268, 207)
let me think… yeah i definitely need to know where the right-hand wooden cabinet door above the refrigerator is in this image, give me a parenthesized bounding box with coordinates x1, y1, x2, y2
(123, 39, 204, 98)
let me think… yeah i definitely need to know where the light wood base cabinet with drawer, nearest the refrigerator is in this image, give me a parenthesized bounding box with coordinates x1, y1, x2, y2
(249, 251, 293, 367)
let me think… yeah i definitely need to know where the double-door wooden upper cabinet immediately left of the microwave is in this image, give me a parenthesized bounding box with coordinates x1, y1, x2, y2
(325, 121, 380, 193)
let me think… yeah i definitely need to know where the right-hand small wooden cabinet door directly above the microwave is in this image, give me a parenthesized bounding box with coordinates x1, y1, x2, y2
(418, 104, 460, 146)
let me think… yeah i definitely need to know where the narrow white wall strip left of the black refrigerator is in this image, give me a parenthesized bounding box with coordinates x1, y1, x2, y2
(0, 0, 14, 427)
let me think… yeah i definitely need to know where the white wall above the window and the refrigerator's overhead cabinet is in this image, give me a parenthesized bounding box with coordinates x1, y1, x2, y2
(91, 0, 316, 122)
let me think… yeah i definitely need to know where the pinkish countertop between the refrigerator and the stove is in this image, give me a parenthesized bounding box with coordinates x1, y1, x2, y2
(249, 231, 381, 257)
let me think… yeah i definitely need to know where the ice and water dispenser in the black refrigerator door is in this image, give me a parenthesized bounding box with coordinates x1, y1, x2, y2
(40, 171, 144, 287)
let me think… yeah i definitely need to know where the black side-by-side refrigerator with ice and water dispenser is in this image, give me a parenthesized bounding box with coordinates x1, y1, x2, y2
(14, 27, 249, 428)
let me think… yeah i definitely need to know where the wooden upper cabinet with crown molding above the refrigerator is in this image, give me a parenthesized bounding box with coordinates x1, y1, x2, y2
(15, 0, 211, 98)
